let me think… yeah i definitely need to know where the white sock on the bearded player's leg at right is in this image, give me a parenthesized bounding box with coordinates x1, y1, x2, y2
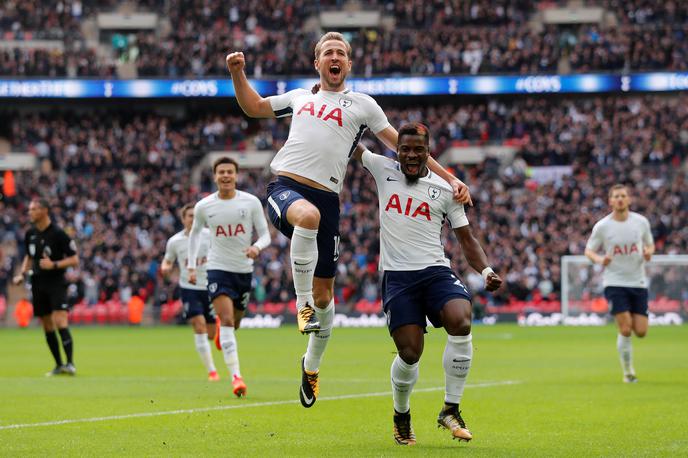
(442, 334, 473, 404)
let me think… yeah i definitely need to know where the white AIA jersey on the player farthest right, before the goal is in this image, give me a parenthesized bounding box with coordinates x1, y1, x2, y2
(586, 212, 654, 288)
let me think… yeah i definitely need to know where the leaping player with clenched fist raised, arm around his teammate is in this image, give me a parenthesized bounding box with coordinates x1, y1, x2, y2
(226, 32, 470, 407)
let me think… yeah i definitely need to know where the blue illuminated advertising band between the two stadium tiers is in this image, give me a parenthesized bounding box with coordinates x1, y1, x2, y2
(0, 72, 688, 99)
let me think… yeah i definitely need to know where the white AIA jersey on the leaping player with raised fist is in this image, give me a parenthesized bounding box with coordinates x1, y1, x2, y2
(268, 89, 389, 193)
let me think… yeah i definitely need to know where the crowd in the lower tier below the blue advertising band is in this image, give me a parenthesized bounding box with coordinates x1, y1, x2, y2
(0, 95, 688, 314)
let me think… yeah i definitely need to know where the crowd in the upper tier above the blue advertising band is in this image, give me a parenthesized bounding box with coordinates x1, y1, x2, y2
(0, 0, 688, 77)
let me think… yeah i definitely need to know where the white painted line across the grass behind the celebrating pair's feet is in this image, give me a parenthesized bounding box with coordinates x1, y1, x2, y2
(0, 380, 521, 430)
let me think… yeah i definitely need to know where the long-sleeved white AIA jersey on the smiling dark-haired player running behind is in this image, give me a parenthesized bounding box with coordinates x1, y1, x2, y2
(189, 190, 270, 273)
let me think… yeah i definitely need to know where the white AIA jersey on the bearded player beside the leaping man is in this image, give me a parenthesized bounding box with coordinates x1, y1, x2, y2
(362, 150, 468, 270)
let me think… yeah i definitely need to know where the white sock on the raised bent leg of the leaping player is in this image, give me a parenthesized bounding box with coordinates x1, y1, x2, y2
(291, 226, 318, 307)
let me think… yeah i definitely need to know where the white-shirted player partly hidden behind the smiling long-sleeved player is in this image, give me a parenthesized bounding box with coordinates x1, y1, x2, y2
(160, 204, 220, 382)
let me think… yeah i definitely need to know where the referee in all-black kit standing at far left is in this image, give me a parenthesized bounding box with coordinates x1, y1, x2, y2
(14, 199, 79, 376)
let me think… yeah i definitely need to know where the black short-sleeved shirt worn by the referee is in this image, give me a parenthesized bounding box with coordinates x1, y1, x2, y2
(24, 223, 76, 283)
